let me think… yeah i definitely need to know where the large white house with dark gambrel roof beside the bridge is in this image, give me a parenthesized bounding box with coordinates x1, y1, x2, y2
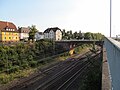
(44, 27, 62, 40)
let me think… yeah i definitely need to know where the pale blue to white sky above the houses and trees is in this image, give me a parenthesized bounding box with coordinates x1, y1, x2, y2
(0, 0, 120, 37)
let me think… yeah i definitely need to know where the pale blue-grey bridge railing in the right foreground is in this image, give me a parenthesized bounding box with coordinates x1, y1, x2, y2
(104, 38, 120, 90)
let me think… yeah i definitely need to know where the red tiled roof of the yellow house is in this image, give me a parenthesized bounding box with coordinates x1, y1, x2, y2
(0, 21, 17, 31)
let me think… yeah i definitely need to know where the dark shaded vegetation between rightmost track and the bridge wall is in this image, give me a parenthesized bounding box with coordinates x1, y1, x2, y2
(79, 51, 102, 90)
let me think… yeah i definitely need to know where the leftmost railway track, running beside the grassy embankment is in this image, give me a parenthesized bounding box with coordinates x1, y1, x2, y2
(9, 49, 100, 90)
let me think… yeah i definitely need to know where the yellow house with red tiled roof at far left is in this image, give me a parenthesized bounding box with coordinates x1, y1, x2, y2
(0, 21, 19, 42)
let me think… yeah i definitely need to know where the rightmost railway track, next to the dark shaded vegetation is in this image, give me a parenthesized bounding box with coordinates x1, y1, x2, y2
(57, 53, 100, 90)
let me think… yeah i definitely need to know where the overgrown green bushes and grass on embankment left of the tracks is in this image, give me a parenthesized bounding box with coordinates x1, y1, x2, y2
(0, 40, 96, 84)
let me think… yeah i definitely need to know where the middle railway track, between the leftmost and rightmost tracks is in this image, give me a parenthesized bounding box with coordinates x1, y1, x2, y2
(35, 51, 101, 90)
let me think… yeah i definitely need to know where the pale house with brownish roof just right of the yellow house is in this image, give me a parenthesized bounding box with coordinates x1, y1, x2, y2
(18, 27, 30, 40)
